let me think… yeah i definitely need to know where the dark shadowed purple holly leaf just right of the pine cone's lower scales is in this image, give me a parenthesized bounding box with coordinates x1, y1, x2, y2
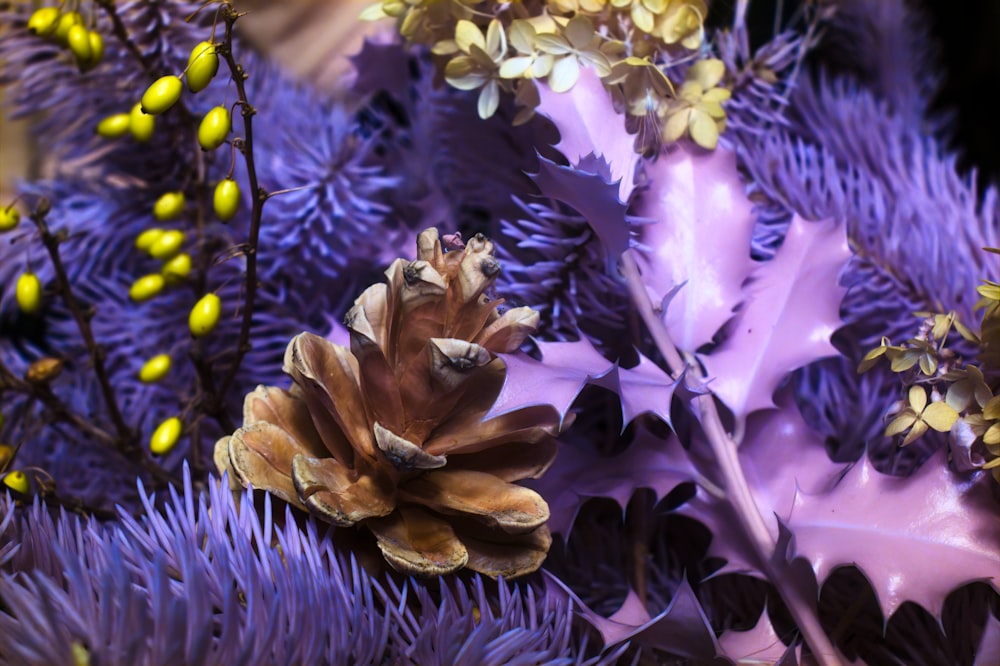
(524, 428, 699, 537)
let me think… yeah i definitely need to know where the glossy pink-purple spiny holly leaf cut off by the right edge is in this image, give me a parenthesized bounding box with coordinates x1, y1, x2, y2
(788, 449, 1000, 617)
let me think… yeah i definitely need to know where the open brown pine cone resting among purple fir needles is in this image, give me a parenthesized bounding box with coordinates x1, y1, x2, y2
(215, 228, 559, 577)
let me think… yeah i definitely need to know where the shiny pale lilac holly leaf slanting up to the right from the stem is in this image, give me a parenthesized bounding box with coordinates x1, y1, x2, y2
(696, 216, 851, 420)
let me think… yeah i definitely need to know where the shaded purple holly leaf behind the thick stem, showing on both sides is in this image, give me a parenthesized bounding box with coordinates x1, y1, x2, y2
(679, 391, 845, 578)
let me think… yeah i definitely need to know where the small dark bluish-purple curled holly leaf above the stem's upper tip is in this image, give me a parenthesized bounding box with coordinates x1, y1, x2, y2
(531, 157, 629, 260)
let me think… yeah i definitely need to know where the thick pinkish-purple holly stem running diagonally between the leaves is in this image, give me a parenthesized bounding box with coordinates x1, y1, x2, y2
(621, 250, 841, 666)
